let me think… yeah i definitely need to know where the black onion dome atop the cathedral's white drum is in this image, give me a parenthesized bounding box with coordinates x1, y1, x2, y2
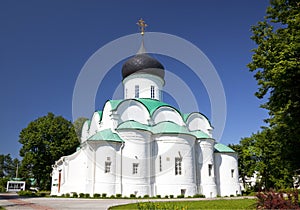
(122, 53, 165, 79)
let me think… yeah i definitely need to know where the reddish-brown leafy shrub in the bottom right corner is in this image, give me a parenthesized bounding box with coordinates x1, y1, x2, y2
(256, 190, 300, 209)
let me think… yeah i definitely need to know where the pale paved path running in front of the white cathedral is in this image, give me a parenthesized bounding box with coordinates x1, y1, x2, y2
(0, 193, 253, 210)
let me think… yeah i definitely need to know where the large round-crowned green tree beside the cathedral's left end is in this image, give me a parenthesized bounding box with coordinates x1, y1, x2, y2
(19, 113, 79, 189)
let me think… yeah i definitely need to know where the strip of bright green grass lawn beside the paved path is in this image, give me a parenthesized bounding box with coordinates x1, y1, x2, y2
(110, 199, 256, 210)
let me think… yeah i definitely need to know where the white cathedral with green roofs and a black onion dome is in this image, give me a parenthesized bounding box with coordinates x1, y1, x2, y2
(51, 23, 241, 197)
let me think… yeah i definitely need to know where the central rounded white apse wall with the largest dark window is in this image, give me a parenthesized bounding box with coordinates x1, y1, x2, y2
(154, 134, 197, 197)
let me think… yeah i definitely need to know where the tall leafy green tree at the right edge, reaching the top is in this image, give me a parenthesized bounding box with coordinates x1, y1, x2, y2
(248, 0, 300, 187)
